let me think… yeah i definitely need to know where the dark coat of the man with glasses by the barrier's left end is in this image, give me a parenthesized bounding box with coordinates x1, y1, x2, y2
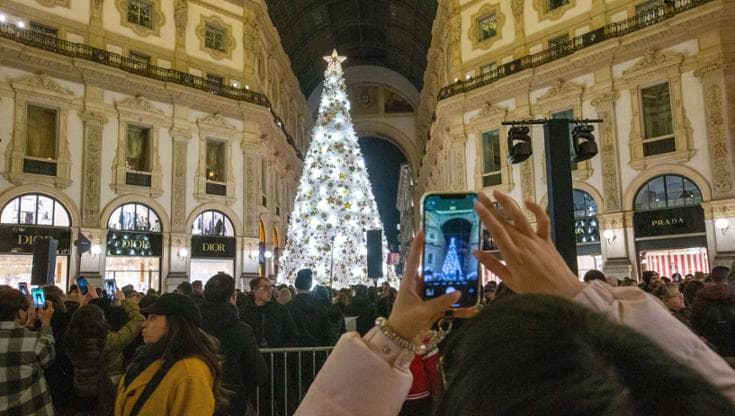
(240, 302, 299, 348)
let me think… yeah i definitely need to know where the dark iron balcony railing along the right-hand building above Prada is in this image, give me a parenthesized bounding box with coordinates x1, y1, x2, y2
(437, 0, 714, 100)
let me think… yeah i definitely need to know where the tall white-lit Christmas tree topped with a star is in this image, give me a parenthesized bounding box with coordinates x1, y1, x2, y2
(278, 50, 387, 287)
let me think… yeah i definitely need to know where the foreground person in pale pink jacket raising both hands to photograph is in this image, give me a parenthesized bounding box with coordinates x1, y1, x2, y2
(296, 192, 735, 415)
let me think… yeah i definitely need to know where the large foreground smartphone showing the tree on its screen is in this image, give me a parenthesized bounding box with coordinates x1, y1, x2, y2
(421, 192, 481, 308)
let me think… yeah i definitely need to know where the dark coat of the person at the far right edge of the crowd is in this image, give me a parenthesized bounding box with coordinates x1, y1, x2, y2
(691, 284, 735, 357)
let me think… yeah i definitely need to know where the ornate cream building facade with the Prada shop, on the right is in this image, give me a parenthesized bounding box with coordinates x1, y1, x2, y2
(415, 0, 735, 279)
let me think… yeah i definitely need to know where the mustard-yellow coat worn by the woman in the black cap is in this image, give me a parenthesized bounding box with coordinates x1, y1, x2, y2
(115, 357, 215, 416)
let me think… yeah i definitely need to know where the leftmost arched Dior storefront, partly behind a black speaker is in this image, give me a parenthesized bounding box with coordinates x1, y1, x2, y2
(0, 194, 71, 290)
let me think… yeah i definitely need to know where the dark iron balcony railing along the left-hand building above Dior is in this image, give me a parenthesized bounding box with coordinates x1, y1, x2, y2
(0, 23, 303, 160)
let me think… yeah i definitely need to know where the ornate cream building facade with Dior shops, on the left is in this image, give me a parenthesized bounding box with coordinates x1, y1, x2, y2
(0, 0, 311, 291)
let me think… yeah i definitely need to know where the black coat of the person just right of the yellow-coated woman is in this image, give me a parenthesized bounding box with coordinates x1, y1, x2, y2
(199, 300, 268, 415)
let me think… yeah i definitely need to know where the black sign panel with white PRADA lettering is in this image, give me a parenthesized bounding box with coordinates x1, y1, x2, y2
(633, 205, 705, 238)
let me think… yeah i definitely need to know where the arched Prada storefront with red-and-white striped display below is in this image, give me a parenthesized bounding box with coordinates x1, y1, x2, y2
(633, 175, 709, 277)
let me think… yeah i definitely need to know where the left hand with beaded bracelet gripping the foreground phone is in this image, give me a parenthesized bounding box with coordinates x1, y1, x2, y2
(387, 231, 462, 344)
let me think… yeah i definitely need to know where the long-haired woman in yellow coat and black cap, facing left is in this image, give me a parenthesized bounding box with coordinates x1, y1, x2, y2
(115, 293, 224, 416)
